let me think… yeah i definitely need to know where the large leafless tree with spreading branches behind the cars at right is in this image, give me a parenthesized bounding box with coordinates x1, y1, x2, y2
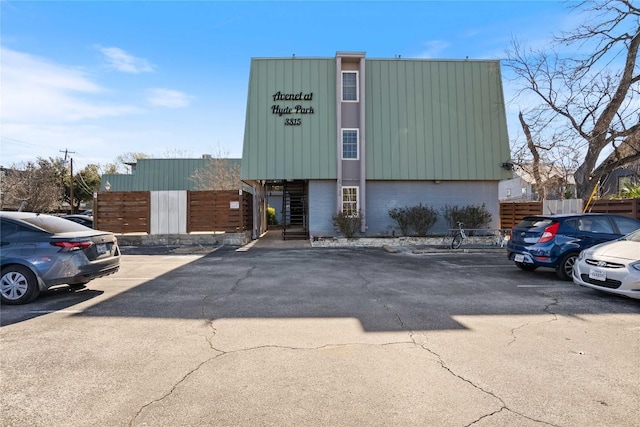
(506, 0, 640, 199)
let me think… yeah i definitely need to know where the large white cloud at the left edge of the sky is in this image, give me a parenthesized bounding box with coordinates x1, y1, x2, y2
(0, 47, 140, 123)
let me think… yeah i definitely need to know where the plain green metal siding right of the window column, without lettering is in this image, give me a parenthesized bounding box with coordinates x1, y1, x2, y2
(365, 59, 510, 180)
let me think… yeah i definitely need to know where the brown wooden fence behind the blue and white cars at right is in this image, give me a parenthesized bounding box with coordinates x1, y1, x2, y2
(500, 199, 640, 228)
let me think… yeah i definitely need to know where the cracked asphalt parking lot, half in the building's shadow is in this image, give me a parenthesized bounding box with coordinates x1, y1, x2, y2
(0, 247, 640, 426)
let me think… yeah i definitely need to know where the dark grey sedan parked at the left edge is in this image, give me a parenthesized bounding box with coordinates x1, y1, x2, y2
(0, 212, 120, 304)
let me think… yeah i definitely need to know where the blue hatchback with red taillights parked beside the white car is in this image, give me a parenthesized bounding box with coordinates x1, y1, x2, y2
(507, 213, 640, 280)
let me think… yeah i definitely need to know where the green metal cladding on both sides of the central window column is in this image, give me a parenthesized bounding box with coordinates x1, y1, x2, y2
(241, 58, 510, 180)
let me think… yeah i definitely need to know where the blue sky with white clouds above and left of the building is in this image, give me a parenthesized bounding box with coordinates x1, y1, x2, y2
(0, 0, 575, 172)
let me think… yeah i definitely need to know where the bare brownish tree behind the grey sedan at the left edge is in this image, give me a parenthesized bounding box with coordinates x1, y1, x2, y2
(0, 158, 64, 213)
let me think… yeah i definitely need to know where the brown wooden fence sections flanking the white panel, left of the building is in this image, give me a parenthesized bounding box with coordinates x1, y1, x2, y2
(93, 190, 253, 234)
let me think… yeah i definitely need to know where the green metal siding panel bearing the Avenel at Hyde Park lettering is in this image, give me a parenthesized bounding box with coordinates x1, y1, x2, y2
(241, 58, 337, 180)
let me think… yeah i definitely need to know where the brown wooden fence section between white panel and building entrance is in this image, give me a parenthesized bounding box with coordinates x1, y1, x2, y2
(187, 190, 253, 233)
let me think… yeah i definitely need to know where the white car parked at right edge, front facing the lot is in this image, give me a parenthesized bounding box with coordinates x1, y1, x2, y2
(573, 229, 640, 299)
